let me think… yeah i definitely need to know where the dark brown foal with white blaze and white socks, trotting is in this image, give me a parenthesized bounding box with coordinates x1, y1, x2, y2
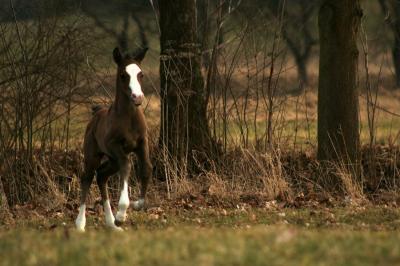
(75, 48, 152, 231)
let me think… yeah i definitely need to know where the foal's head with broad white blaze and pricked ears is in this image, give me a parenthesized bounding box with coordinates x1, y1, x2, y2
(113, 47, 147, 106)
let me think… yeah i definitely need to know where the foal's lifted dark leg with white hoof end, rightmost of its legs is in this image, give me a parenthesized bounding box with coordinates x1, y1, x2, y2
(133, 139, 152, 210)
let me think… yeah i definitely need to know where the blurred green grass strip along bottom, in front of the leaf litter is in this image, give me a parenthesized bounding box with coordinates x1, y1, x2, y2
(0, 226, 400, 265)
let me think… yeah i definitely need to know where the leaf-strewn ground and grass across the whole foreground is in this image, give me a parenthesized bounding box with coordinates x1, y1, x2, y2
(0, 201, 400, 265)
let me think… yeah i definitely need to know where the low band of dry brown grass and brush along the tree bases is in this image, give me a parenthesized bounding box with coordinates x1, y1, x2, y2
(3, 141, 400, 224)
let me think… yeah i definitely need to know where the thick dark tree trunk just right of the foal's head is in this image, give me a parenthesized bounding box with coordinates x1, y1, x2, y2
(159, 0, 213, 172)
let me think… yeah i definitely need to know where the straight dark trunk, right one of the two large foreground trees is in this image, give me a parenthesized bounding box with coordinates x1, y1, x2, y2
(318, 0, 362, 164)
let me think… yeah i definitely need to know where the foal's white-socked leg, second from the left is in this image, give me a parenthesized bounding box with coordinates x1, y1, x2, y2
(96, 160, 122, 231)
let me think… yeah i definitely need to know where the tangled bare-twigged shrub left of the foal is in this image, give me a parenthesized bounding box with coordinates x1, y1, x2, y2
(0, 5, 95, 204)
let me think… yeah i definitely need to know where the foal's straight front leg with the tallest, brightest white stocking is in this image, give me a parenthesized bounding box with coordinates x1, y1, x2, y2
(115, 155, 131, 226)
